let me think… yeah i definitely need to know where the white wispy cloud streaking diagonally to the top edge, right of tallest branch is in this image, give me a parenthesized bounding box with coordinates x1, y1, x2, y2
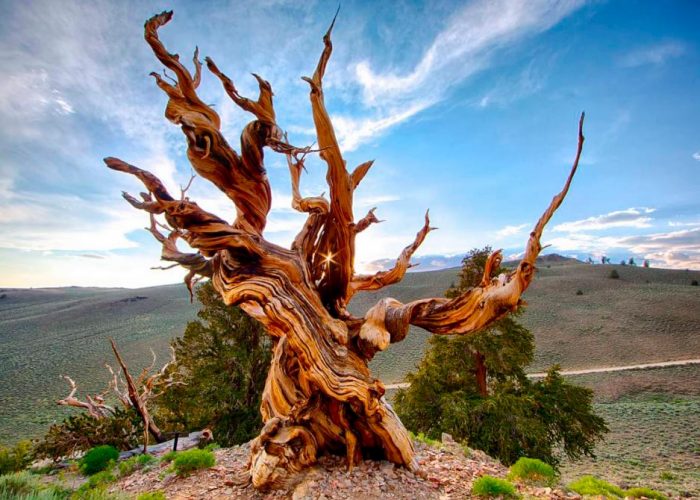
(336, 0, 584, 150)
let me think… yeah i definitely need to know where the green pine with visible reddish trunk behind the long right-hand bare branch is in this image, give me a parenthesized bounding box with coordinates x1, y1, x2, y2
(395, 247, 607, 465)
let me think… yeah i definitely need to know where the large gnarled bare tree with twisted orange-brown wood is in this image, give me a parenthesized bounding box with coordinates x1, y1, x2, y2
(105, 12, 583, 487)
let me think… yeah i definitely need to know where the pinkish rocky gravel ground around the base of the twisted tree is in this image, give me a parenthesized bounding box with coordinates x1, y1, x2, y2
(112, 436, 580, 500)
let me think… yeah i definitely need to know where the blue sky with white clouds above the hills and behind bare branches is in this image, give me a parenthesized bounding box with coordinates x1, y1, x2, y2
(0, 0, 700, 287)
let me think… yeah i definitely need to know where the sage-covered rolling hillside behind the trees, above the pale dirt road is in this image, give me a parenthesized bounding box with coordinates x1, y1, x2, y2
(0, 256, 700, 442)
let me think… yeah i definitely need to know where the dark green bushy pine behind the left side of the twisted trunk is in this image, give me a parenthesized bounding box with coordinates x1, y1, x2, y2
(156, 282, 272, 446)
